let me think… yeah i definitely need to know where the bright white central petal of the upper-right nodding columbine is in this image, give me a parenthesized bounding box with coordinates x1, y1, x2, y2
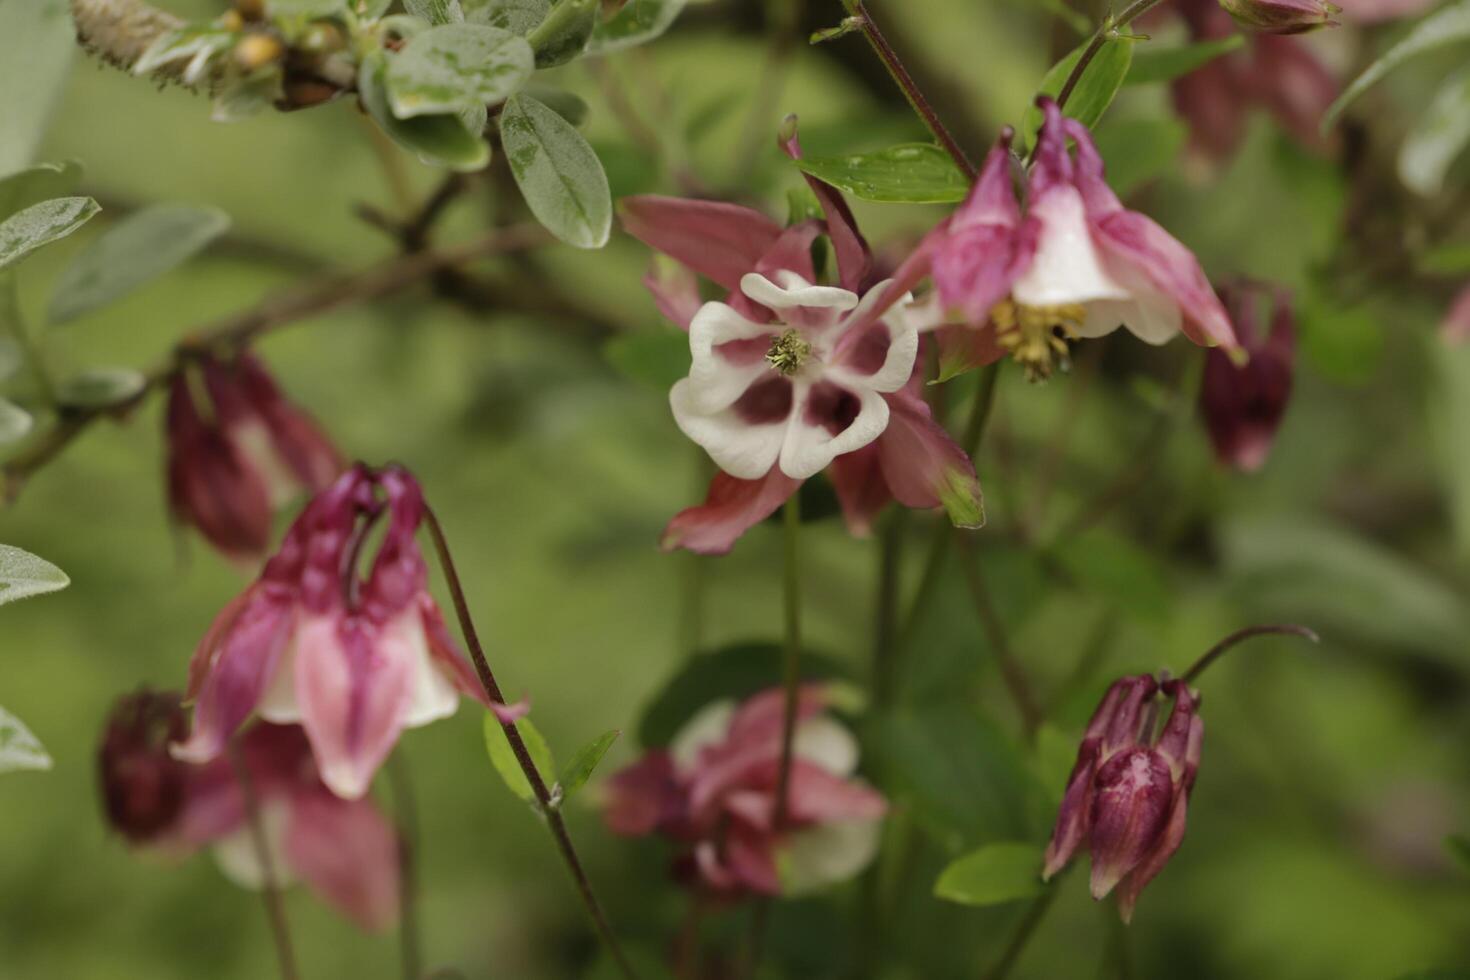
(1011, 187, 1127, 306)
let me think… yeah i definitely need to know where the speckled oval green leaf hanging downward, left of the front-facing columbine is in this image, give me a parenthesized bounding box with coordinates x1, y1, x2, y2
(500, 96, 613, 248)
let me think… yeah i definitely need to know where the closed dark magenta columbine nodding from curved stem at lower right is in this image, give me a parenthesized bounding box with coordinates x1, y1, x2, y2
(1042, 674, 1204, 923)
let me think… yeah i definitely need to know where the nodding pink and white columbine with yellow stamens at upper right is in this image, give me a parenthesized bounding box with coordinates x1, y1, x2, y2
(876, 97, 1236, 379)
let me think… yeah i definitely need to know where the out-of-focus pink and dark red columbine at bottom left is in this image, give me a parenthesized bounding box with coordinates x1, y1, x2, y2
(98, 691, 398, 930)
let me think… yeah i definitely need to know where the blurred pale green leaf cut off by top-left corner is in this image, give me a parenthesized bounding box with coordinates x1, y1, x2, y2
(0, 0, 76, 173)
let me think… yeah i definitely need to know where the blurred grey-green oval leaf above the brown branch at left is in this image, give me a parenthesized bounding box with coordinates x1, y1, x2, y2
(49, 204, 229, 323)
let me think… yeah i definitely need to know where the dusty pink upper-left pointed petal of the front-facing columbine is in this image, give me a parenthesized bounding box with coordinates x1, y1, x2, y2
(620, 194, 782, 291)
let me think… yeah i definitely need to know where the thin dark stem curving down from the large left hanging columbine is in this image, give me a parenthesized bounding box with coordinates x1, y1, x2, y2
(423, 505, 638, 980)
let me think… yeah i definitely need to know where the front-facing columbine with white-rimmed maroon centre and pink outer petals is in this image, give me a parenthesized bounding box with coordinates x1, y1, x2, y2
(622, 127, 983, 554)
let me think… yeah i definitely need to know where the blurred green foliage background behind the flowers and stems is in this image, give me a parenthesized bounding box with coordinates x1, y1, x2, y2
(0, 0, 1470, 980)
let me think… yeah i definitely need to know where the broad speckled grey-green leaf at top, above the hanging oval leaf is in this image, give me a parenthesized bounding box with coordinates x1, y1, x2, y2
(384, 24, 535, 119)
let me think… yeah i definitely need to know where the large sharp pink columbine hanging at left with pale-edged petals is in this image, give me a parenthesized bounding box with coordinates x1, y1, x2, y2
(175, 464, 509, 799)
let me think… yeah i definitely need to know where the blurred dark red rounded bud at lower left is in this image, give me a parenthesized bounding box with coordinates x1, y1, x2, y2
(97, 689, 188, 843)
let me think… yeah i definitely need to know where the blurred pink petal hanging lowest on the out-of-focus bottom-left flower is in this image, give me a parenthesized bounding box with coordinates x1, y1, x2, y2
(285, 790, 400, 932)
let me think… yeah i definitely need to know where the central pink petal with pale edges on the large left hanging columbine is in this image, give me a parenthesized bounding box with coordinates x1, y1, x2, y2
(295, 616, 415, 799)
